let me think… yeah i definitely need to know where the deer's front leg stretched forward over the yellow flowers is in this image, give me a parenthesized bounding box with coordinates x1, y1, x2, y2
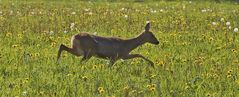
(122, 54, 154, 67)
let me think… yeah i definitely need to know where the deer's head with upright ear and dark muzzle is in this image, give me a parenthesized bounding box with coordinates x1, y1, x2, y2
(143, 23, 159, 45)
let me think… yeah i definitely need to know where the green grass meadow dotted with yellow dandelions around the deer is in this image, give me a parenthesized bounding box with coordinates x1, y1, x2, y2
(0, 0, 239, 97)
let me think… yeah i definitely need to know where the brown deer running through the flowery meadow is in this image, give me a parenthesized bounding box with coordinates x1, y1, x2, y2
(57, 23, 159, 67)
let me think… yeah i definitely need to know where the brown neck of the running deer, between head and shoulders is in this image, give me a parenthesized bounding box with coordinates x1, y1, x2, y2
(127, 34, 146, 51)
